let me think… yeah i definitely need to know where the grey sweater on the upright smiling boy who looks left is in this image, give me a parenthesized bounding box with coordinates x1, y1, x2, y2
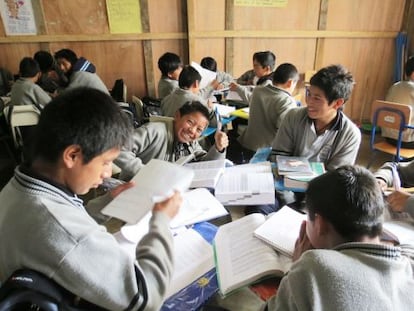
(272, 107, 361, 170)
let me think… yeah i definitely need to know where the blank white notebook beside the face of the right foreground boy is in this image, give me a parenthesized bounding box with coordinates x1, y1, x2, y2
(254, 205, 307, 257)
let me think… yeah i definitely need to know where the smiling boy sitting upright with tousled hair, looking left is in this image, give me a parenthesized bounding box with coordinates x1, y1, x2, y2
(272, 65, 361, 170)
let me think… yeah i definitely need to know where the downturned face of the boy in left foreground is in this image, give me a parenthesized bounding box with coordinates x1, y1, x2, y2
(65, 148, 119, 194)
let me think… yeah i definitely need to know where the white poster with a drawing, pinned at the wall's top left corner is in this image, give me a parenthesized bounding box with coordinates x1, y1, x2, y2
(0, 0, 37, 36)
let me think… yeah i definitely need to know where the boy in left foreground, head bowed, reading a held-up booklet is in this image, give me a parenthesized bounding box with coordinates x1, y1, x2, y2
(0, 88, 181, 310)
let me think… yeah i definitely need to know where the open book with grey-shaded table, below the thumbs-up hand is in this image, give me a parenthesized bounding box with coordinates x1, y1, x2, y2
(214, 162, 275, 205)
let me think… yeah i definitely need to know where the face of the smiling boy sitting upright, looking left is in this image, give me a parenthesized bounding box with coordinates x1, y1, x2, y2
(306, 85, 343, 120)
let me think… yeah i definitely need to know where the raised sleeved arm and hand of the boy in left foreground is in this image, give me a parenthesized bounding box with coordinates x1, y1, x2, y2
(52, 212, 173, 310)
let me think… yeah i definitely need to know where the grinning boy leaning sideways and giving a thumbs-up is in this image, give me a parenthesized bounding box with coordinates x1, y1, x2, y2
(114, 101, 229, 180)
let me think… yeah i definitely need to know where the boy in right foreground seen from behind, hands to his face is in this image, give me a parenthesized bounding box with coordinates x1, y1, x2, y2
(266, 166, 414, 310)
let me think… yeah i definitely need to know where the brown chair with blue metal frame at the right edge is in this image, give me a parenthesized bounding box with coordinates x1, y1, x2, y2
(367, 100, 414, 168)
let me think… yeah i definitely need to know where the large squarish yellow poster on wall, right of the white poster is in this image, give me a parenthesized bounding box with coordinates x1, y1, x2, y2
(106, 0, 142, 33)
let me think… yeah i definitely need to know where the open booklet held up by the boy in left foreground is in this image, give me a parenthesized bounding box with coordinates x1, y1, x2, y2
(102, 159, 194, 223)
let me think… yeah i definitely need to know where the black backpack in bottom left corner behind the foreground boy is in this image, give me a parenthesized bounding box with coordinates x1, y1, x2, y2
(0, 269, 105, 311)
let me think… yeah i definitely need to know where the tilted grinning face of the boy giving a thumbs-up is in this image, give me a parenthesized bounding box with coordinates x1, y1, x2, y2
(174, 111, 208, 143)
